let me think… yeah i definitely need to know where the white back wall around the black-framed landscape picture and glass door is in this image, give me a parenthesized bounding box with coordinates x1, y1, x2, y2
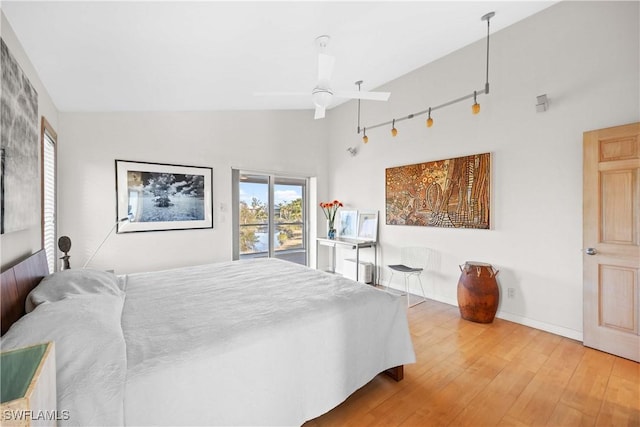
(58, 111, 327, 273)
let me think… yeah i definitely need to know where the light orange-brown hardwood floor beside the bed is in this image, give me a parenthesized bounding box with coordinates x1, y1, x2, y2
(305, 300, 640, 427)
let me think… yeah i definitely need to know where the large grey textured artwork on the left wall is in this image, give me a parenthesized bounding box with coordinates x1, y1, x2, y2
(0, 39, 40, 234)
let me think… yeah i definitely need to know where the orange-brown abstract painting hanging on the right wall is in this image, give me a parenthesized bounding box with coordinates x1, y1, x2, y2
(385, 153, 491, 229)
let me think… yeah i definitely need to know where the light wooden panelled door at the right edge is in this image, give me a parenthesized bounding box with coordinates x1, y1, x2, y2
(583, 123, 640, 361)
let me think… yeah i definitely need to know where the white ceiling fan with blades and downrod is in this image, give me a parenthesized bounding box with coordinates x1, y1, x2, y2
(256, 35, 391, 119)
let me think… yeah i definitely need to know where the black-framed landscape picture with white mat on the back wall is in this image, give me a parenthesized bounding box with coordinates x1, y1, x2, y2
(115, 160, 213, 233)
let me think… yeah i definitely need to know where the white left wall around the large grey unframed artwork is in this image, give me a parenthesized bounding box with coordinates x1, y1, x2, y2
(0, 13, 58, 269)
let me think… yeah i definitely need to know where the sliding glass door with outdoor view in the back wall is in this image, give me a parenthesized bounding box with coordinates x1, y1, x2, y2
(233, 170, 308, 265)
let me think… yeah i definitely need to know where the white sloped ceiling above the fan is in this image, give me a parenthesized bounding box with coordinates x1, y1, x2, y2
(1, 0, 554, 111)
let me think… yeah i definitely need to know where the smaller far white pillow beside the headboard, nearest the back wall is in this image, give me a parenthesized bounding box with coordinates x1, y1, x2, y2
(25, 269, 124, 313)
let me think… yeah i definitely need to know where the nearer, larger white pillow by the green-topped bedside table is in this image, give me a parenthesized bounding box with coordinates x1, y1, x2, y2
(0, 295, 127, 426)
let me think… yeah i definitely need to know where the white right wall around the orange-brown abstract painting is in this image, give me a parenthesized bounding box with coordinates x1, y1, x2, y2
(328, 2, 640, 339)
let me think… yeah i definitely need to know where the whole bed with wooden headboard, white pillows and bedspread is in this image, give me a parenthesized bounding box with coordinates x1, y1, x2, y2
(0, 254, 415, 425)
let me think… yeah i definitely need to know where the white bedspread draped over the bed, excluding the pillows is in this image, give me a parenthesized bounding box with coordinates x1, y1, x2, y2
(122, 259, 415, 425)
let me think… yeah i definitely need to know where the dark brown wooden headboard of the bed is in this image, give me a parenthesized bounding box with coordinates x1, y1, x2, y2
(0, 249, 49, 335)
